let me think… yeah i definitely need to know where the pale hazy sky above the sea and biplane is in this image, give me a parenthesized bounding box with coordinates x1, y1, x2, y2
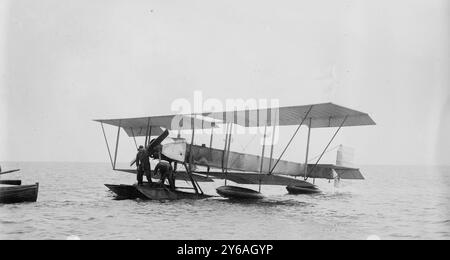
(0, 0, 450, 164)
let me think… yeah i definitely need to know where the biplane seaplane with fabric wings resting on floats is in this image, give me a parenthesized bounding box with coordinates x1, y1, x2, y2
(95, 103, 375, 200)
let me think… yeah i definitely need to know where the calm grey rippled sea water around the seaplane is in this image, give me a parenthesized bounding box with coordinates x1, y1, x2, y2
(0, 163, 450, 239)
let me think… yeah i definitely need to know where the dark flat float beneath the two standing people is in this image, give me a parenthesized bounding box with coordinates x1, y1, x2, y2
(105, 183, 211, 200)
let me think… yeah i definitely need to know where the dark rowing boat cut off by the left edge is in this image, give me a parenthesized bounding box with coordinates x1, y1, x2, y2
(0, 183, 39, 204)
